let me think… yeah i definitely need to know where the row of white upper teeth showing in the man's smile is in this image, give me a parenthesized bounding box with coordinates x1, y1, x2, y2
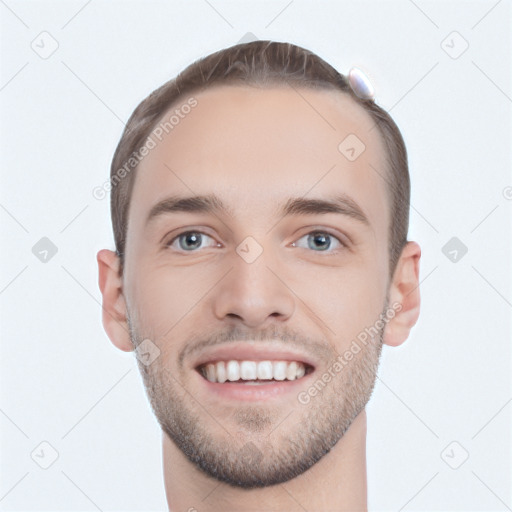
(201, 361, 306, 383)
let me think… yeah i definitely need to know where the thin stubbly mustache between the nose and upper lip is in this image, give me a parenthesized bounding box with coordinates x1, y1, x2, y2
(178, 326, 338, 369)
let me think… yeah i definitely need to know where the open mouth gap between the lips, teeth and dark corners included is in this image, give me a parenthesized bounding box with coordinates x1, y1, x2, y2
(196, 359, 314, 385)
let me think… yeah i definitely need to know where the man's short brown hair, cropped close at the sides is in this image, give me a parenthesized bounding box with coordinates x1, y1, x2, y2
(110, 41, 410, 277)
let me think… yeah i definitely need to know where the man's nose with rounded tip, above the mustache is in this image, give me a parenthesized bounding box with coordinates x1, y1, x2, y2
(214, 246, 296, 328)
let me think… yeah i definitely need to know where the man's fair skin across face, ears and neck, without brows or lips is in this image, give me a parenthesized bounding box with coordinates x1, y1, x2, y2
(97, 86, 421, 512)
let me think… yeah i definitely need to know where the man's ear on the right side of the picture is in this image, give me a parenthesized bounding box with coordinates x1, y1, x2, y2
(383, 242, 421, 347)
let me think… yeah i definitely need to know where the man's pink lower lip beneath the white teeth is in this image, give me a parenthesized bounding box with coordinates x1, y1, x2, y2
(197, 372, 314, 401)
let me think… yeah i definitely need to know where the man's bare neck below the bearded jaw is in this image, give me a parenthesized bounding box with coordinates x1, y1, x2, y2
(162, 409, 367, 512)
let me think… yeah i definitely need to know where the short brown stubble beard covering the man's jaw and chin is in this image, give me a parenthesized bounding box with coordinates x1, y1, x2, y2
(129, 312, 384, 489)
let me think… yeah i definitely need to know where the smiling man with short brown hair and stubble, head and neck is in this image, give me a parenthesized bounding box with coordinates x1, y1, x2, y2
(97, 41, 421, 512)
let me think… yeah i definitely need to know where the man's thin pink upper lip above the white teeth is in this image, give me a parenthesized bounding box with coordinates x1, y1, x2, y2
(193, 341, 316, 368)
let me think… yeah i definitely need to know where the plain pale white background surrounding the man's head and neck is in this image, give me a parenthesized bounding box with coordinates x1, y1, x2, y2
(0, 0, 512, 511)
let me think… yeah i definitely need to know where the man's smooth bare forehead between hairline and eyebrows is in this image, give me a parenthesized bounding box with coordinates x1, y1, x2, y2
(129, 86, 389, 236)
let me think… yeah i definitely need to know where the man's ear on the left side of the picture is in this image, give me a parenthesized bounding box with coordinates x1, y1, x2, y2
(96, 249, 134, 352)
